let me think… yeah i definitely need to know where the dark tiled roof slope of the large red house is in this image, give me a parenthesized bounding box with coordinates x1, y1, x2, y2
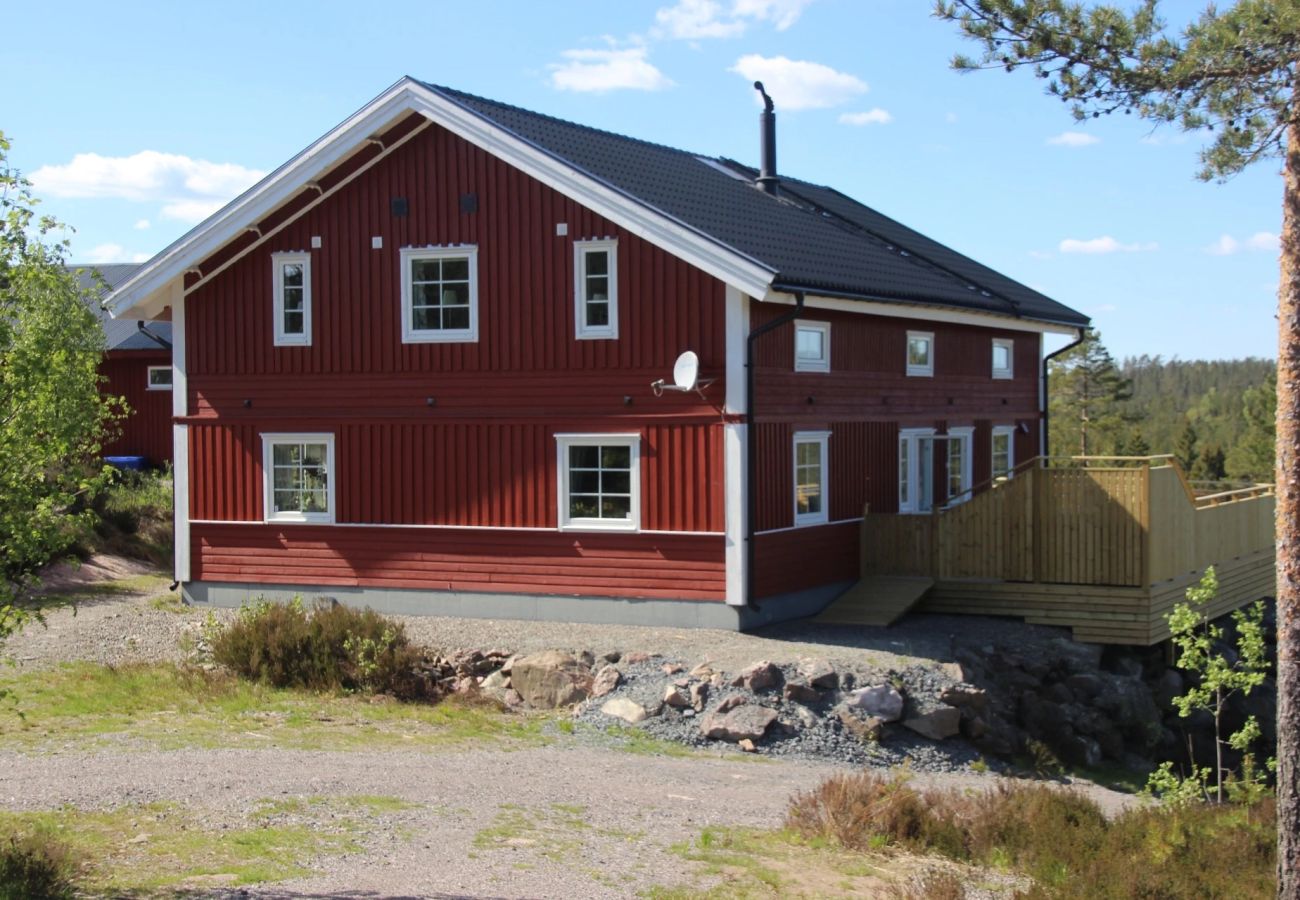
(425, 85, 1088, 325)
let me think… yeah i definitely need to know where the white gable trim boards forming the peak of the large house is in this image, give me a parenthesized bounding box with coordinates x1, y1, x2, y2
(107, 77, 775, 317)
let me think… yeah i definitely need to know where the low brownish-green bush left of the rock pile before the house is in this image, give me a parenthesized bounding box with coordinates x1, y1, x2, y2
(212, 600, 441, 700)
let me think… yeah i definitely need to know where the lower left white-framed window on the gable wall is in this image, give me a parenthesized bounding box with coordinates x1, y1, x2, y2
(261, 433, 335, 523)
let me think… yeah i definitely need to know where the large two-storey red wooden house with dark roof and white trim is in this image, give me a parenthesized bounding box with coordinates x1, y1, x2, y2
(111, 78, 1087, 627)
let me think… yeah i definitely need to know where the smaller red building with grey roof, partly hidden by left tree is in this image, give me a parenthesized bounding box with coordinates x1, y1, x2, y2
(70, 263, 172, 466)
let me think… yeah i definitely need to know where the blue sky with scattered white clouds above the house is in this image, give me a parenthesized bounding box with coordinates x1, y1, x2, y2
(0, 0, 1282, 359)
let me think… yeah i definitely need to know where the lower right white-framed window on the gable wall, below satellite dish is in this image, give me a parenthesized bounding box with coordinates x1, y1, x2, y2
(555, 434, 641, 531)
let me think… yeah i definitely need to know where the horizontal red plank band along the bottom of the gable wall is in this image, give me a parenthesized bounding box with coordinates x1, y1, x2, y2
(191, 524, 727, 601)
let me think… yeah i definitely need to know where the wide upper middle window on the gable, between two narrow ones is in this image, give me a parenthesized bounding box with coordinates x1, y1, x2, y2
(399, 245, 478, 343)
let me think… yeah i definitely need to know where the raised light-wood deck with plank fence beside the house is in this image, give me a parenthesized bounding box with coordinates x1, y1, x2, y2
(857, 457, 1275, 645)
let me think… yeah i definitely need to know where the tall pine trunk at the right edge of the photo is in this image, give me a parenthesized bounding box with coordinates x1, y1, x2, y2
(1277, 119, 1300, 900)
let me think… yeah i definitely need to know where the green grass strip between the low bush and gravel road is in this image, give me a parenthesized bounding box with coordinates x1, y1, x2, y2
(0, 663, 549, 750)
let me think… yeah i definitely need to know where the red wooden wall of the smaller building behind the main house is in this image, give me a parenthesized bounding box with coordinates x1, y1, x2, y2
(99, 347, 172, 464)
